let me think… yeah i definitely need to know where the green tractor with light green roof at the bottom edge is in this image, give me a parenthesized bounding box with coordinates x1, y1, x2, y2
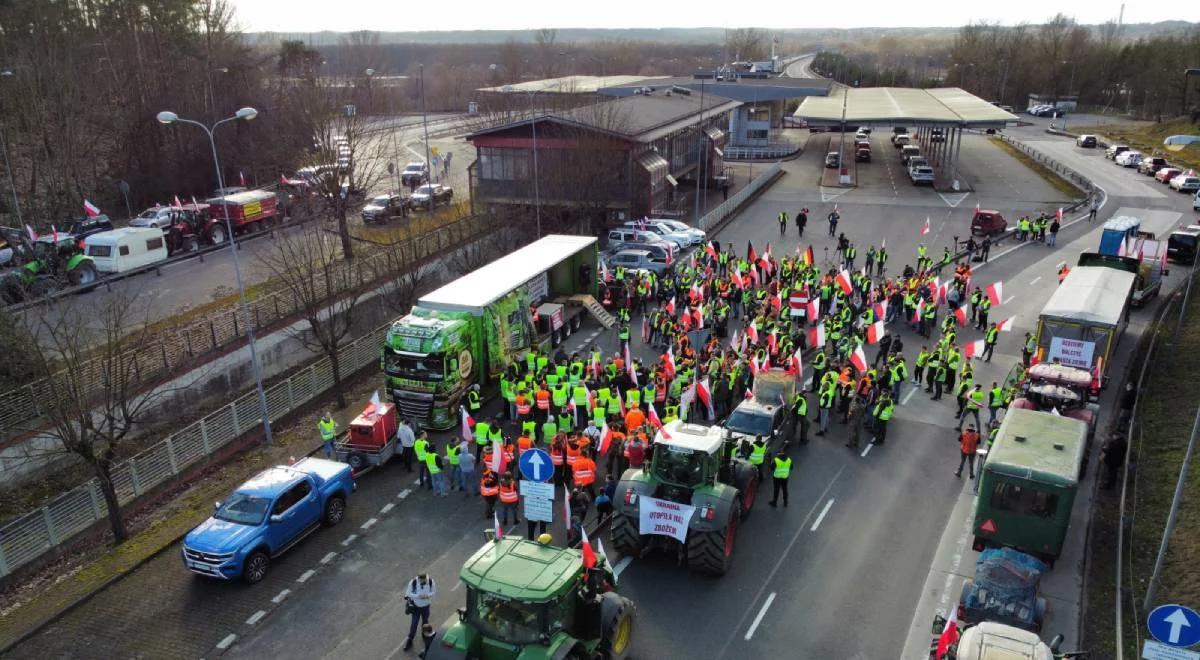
(427, 535, 636, 660)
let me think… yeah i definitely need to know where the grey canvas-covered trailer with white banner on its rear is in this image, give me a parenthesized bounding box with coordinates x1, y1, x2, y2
(1033, 266, 1134, 386)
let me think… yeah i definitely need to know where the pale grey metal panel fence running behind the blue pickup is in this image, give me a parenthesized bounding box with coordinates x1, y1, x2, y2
(0, 323, 391, 577)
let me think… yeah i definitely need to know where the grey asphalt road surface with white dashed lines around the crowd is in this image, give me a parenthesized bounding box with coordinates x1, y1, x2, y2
(11, 120, 1192, 659)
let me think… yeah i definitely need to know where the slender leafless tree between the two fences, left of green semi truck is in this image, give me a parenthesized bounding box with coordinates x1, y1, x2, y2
(262, 222, 367, 408)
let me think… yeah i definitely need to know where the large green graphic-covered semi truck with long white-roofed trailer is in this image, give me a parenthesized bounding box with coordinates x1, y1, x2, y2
(380, 234, 596, 430)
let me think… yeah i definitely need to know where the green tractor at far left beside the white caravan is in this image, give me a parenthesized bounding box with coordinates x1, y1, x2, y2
(0, 229, 100, 305)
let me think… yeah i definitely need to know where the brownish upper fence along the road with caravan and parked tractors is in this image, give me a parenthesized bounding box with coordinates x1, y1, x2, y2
(0, 216, 487, 430)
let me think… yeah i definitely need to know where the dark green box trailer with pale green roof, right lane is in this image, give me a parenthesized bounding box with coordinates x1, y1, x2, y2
(973, 408, 1087, 565)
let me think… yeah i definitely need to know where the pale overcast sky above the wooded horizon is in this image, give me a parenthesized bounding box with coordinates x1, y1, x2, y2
(230, 0, 1180, 32)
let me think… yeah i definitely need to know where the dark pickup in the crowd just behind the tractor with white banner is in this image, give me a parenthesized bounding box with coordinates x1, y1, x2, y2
(725, 368, 797, 452)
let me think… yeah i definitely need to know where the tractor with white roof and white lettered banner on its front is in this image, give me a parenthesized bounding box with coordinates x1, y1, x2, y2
(612, 420, 761, 575)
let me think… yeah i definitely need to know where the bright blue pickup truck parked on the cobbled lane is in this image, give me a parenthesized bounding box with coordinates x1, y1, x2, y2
(182, 458, 355, 584)
